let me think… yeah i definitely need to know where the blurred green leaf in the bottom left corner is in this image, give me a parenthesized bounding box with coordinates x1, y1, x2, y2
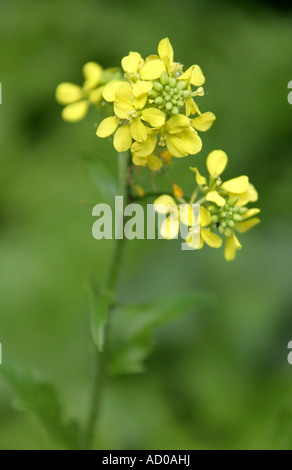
(0, 364, 80, 449)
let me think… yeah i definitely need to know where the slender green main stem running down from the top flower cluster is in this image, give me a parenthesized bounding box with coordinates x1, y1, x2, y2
(84, 152, 129, 450)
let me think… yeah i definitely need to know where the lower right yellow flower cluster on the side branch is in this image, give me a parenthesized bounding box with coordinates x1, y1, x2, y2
(154, 150, 260, 261)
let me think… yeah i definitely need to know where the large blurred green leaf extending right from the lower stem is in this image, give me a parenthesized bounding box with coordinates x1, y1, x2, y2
(107, 292, 203, 375)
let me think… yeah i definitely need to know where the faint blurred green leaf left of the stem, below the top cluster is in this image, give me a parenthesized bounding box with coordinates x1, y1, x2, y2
(74, 152, 118, 204)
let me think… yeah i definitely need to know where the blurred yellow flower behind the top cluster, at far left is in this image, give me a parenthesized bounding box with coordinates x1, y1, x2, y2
(56, 62, 118, 122)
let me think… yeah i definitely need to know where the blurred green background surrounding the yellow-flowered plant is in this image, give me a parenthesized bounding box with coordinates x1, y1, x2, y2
(0, 0, 292, 449)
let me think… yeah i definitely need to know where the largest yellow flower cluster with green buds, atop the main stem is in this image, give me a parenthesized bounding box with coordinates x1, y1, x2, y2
(97, 38, 215, 170)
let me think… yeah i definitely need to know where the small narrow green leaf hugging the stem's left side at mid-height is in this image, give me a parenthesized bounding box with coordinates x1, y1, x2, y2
(87, 283, 110, 352)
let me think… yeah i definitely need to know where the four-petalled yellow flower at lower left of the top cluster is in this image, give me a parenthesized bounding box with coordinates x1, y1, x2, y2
(96, 82, 165, 152)
